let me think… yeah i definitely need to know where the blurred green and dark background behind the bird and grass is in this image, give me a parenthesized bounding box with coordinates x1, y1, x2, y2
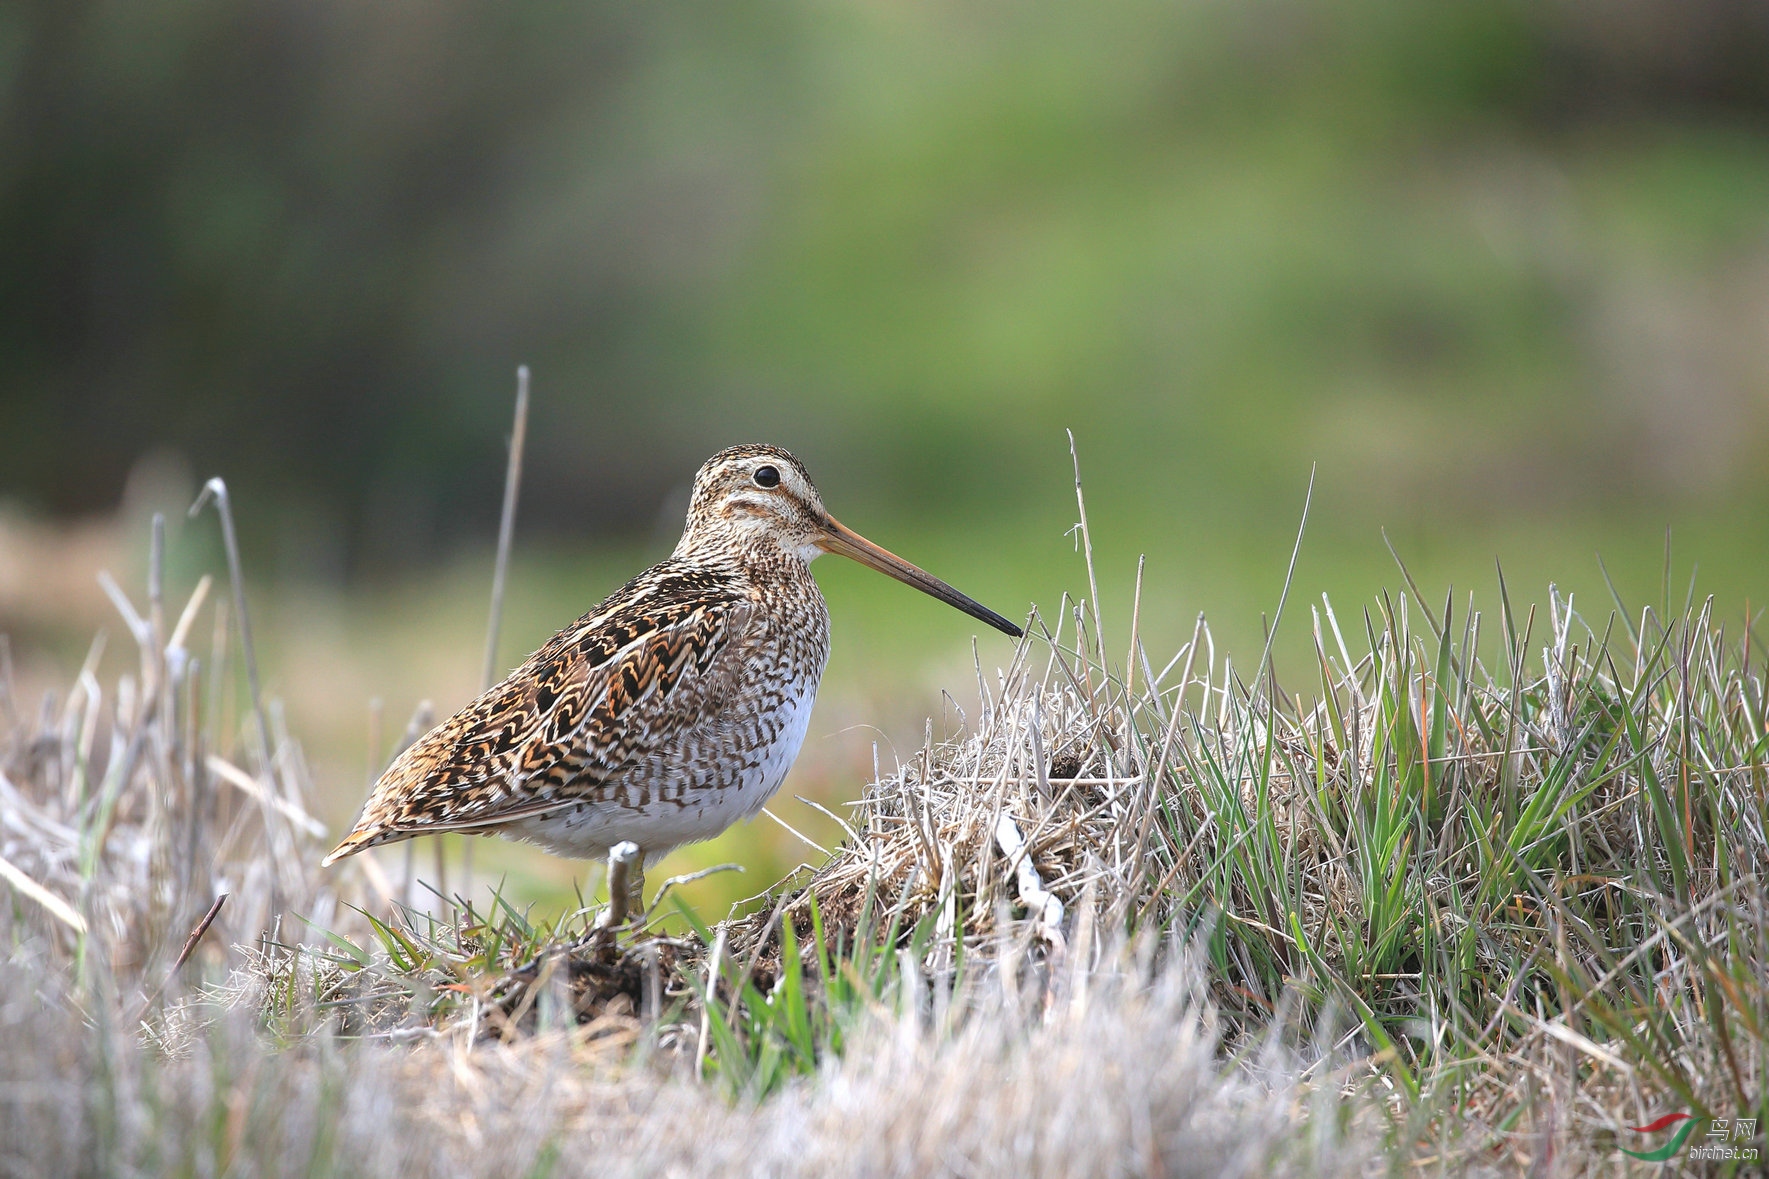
(10, 0, 1769, 901)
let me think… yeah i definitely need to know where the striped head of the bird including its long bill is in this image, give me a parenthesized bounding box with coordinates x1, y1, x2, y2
(676, 446, 1021, 639)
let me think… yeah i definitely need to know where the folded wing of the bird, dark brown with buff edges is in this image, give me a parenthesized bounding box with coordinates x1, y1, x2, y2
(325, 563, 754, 864)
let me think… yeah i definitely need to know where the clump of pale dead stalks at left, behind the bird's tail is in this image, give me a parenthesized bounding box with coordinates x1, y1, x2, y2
(0, 499, 336, 1018)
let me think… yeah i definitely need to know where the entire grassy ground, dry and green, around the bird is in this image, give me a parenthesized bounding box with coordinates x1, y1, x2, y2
(0, 509, 1769, 1175)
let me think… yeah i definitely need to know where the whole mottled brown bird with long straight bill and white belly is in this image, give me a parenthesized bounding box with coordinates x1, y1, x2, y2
(325, 446, 1019, 881)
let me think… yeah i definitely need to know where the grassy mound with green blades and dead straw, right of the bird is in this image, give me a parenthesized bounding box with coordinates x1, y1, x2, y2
(732, 559, 1769, 1174)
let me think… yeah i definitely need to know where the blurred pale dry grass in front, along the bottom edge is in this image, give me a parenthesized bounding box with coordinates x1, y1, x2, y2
(0, 920, 1369, 1175)
